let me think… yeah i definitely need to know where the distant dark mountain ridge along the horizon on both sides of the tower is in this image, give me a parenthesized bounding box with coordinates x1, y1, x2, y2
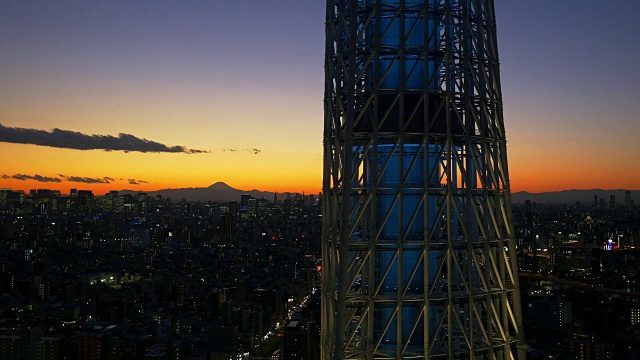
(120, 182, 640, 204)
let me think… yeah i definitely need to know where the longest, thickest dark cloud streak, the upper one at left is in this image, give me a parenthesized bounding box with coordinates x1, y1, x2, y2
(0, 124, 209, 154)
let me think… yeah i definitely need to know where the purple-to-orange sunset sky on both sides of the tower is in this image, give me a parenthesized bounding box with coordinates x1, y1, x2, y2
(0, 0, 640, 194)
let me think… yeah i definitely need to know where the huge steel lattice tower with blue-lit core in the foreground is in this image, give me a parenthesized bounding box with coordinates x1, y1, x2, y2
(321, 0, 524, 359)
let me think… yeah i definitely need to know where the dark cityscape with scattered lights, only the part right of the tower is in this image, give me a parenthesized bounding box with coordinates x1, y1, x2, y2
(513, 191, 640, 359)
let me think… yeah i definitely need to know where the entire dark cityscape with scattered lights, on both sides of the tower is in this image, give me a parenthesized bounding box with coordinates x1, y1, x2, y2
(0, 189, 640, 360)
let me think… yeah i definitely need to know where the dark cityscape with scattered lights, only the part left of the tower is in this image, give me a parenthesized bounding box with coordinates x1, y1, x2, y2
(0, 190, 320, 360)
